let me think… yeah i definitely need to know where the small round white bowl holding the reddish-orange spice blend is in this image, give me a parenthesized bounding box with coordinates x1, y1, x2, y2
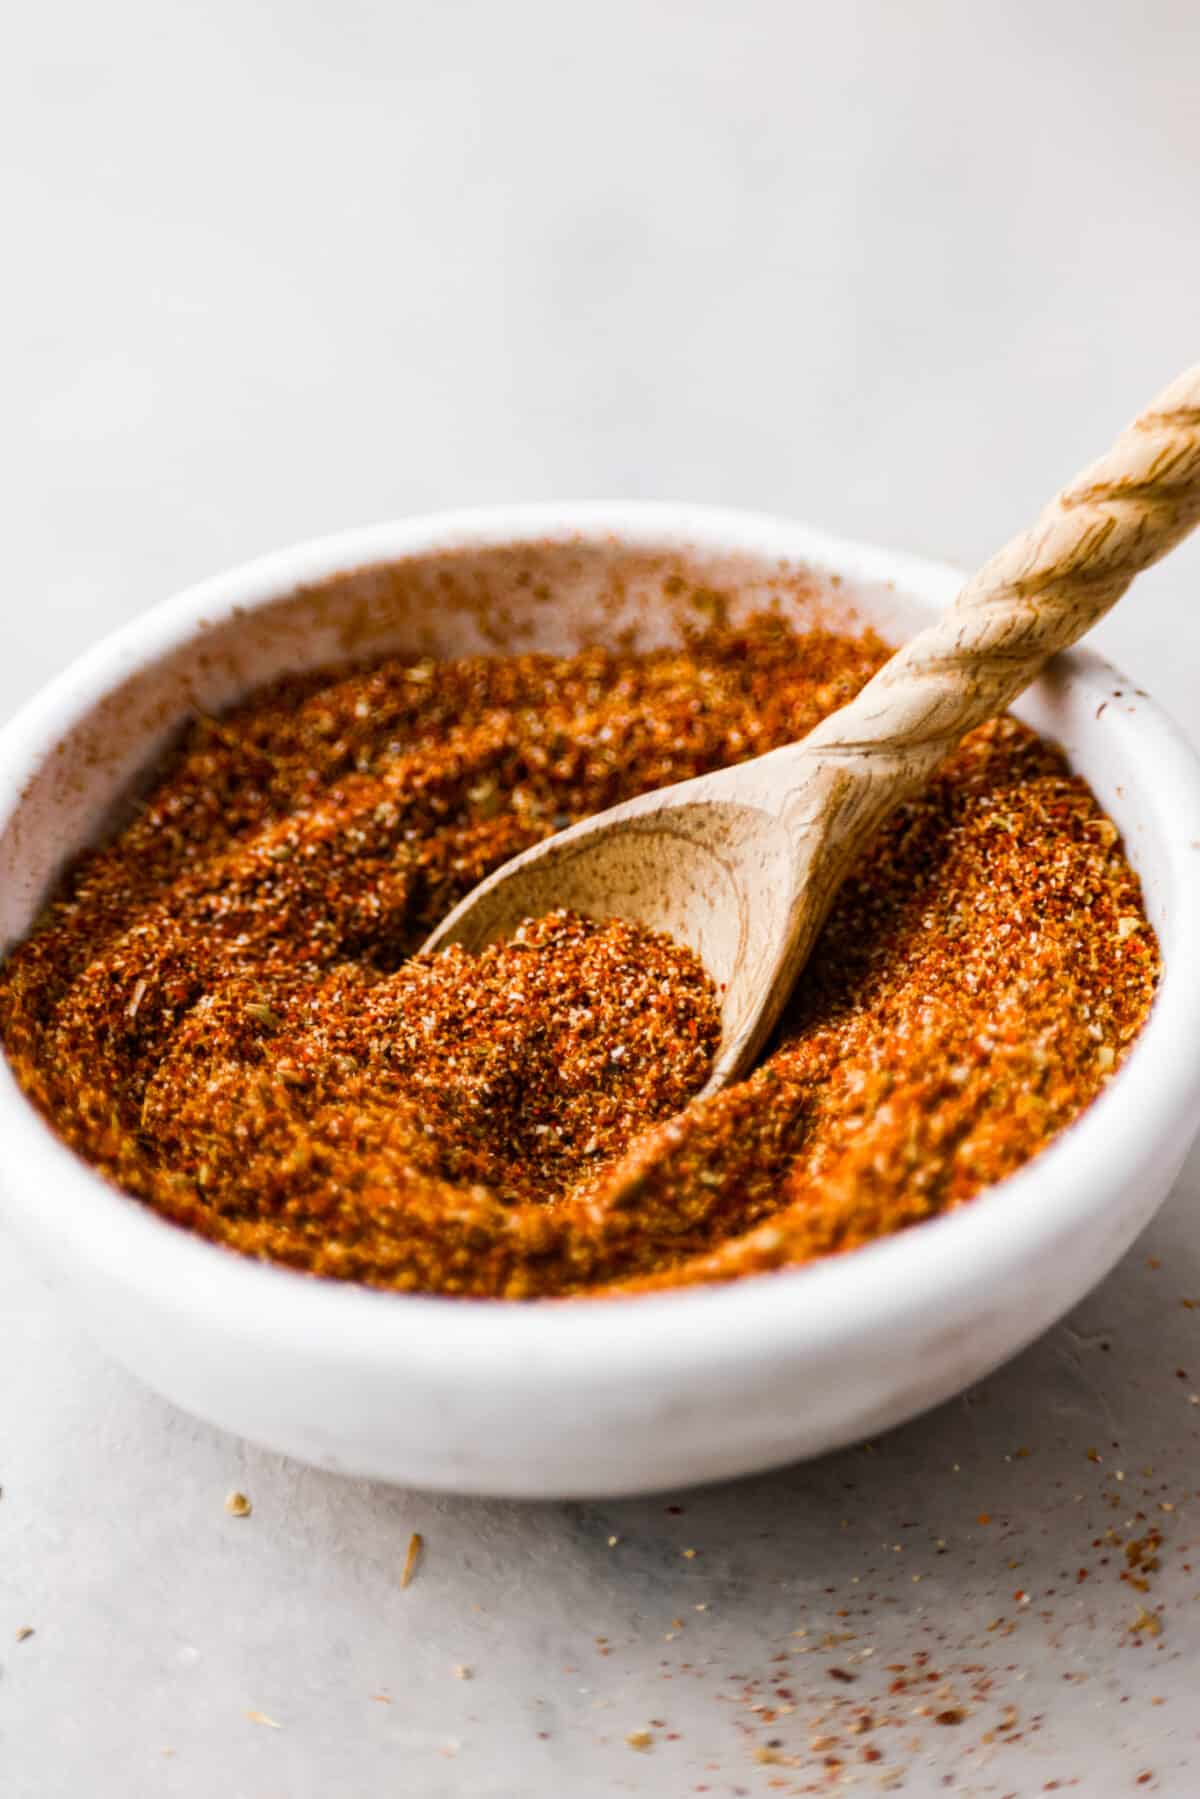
(0, 506, 1200, 1495)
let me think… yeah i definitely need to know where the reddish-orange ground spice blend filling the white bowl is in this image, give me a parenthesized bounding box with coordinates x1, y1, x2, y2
(0, 615, 1159, 1299)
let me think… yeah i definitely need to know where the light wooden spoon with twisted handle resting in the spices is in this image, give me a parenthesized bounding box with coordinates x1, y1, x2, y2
(425, 363, 1200, 1092)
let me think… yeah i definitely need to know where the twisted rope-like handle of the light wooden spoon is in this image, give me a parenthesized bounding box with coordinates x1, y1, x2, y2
(804, 363, 1200, 791)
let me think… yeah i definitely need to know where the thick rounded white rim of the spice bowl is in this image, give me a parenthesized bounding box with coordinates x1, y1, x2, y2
(0, 502, 1200, 1400)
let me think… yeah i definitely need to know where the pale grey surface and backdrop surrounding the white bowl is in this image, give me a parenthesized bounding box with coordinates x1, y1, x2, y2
(0, 0, 1200, 1799)
